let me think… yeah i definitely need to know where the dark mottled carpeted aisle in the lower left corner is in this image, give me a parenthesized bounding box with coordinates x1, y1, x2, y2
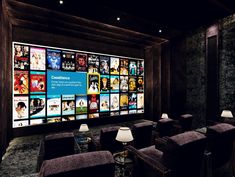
(0, 135, 42, 177)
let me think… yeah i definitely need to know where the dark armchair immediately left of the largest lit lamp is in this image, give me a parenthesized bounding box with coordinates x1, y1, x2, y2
(89, 126, 123, 153)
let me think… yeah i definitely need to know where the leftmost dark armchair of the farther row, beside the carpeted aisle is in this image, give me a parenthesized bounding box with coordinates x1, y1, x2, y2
(37, 132, 75, 171)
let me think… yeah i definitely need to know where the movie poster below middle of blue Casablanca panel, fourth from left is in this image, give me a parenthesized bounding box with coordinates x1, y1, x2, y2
(62, 95, 75, 115)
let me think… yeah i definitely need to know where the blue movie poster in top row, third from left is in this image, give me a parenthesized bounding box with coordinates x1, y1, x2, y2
(47, 49, 61, 70)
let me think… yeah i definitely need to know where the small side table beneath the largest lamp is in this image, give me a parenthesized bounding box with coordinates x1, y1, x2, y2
(113, 151, 133, 177)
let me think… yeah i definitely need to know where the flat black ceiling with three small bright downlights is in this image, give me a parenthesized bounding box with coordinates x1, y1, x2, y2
(16, 0, 235, 36)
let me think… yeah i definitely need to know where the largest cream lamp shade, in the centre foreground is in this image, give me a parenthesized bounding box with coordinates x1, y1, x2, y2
(116, 127, 133, 143)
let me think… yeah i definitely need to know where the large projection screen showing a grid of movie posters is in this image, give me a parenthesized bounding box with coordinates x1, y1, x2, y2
(12, 42, 144, 128)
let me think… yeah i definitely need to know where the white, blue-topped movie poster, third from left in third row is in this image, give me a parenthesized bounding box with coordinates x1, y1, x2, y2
(47, 95, 61, 116)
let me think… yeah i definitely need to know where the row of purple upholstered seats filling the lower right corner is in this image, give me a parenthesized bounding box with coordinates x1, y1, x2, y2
(128, 123, 235, 177)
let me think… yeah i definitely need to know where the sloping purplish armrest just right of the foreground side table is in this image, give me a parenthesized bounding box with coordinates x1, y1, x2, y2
(126, 146, 171, 177)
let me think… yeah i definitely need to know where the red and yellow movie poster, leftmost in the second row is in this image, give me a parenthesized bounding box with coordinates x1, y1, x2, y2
(14, 70, 29, 94)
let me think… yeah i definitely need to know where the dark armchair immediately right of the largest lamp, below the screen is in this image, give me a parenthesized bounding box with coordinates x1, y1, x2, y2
(132, 121, 153, 149)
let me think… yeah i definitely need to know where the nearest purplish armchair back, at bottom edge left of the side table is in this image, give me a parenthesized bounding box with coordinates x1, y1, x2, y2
(39, 151, 115, 177)
